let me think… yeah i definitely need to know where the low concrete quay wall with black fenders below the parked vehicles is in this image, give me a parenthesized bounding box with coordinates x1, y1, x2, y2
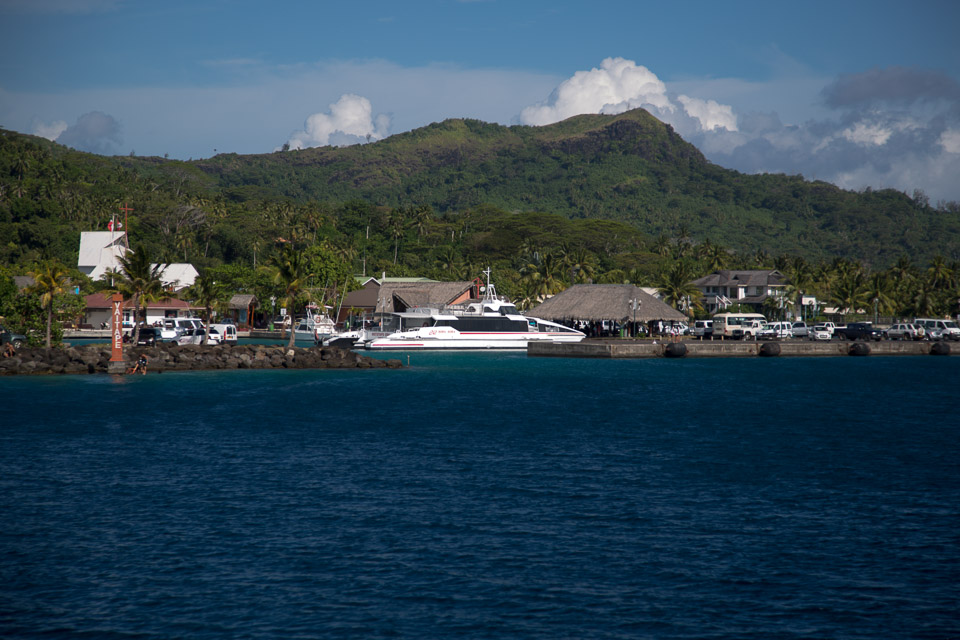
(527, 340, 960, 358)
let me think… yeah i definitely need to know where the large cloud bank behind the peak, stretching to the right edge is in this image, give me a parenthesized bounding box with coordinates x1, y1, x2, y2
(519, 58, 960, 200)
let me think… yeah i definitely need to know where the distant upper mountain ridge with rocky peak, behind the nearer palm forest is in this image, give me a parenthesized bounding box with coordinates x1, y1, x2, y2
(196, 109, 960, 265)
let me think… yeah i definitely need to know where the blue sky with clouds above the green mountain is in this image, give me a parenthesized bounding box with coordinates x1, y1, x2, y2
(0, 0, 960, 202)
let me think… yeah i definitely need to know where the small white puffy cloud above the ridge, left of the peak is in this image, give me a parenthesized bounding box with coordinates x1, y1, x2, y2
(287, 93, 390, 149)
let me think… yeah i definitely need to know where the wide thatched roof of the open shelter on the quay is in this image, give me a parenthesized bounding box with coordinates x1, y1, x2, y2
(530, 284, 687, 322)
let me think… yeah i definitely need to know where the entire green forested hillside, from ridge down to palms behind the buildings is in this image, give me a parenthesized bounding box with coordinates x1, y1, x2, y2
(0, 110, 960, 320)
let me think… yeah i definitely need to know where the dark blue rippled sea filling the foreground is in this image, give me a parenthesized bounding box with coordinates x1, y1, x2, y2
(0, 353, 960, 640)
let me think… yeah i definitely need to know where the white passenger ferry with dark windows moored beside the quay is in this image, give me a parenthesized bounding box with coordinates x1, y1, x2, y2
(358, 269, 586, 351)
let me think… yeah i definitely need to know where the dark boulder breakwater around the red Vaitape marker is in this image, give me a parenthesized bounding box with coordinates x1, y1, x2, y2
(0, 343, 403, 375)
